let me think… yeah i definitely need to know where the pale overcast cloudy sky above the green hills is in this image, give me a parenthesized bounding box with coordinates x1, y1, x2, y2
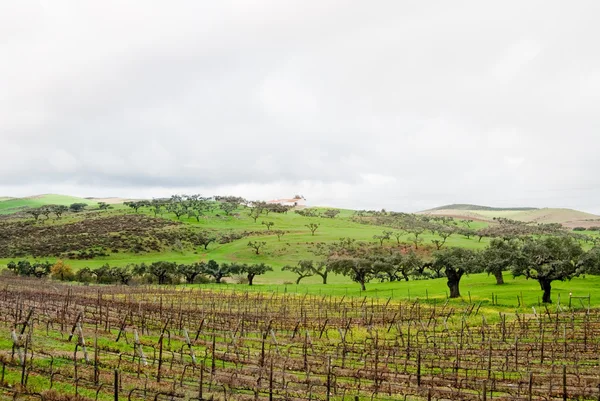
(0, 0, 600, 213)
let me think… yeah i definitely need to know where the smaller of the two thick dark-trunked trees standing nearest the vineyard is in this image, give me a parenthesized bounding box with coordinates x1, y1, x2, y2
(433, 248, 481, 298)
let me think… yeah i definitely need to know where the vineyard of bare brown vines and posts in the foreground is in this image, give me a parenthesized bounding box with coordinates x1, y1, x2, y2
(0, 278, 600, 400)
